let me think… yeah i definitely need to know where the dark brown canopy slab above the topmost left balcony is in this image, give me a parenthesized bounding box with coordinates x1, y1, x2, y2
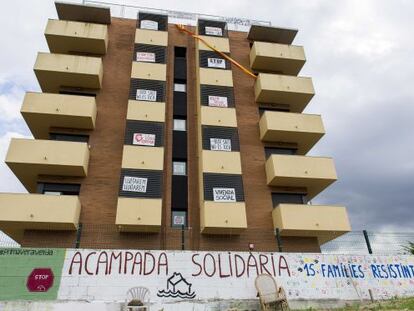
(55, 1, 111, 24)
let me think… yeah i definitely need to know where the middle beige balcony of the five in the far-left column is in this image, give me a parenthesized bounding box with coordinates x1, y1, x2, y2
(20, 92, 96, 139)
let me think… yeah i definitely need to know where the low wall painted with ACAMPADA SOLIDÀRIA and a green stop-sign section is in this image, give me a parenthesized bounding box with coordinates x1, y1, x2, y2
(0, 249, 414, 303)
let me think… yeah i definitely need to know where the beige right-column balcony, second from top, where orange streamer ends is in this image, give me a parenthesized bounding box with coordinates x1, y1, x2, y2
(254, 73, 315, 112)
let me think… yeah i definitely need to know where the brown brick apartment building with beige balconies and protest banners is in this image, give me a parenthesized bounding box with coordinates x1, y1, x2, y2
(0, 2, 351, 252)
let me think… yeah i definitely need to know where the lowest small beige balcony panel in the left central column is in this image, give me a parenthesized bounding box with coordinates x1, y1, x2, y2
(115, 198, 162, 232)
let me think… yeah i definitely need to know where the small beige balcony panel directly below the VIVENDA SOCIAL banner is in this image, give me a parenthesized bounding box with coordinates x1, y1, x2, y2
(201, 201, 247, 234)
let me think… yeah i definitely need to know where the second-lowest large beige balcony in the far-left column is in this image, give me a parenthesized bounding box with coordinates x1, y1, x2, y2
(6, 138, 89, 192)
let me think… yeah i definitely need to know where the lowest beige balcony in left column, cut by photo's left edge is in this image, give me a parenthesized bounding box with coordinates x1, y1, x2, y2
(0, 193, 81, 243)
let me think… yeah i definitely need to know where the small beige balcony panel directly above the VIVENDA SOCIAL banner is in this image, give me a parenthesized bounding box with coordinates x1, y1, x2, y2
(202, 150, 241, 174)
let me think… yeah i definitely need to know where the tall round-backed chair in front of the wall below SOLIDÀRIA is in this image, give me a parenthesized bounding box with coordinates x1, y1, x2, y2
(254, 274, 289, 311)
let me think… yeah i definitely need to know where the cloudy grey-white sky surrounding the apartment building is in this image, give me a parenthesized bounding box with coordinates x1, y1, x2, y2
(0, 0, 414, 231)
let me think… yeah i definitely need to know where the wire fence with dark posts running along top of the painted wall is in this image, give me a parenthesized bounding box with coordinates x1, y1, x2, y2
(0, 224, 414, 255)
